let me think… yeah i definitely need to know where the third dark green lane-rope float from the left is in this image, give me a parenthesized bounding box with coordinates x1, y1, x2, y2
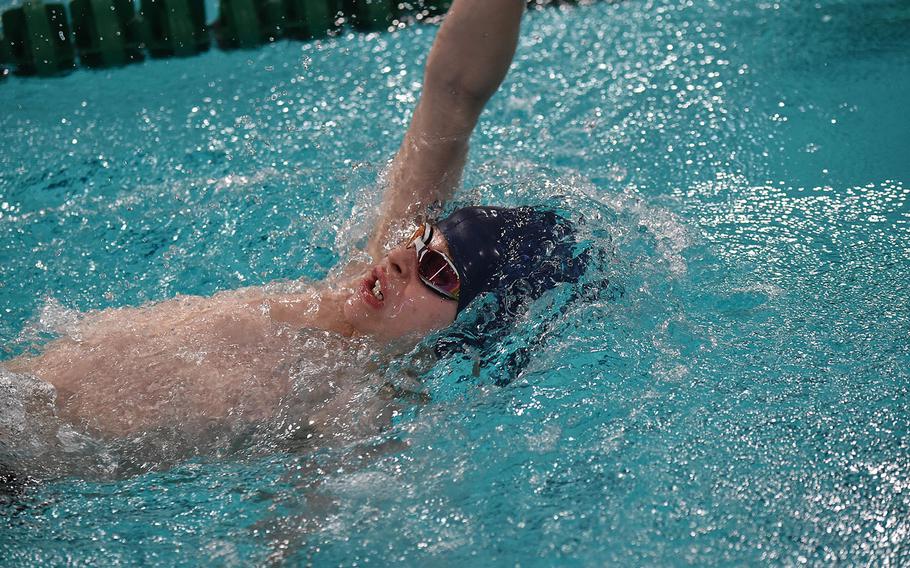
(139, 0, 211, 57)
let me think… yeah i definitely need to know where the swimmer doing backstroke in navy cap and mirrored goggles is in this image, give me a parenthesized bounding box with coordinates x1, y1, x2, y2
(0, 0, 583, 438)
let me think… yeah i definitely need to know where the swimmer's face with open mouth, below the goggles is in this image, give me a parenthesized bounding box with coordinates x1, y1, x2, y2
(344, 227, 458, 340)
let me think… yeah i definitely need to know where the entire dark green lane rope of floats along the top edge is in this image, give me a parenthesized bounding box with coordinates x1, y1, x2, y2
(0, 0, 575, 79)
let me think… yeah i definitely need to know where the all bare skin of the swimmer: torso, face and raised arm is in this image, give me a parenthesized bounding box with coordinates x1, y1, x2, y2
(0, 0, 525, 436)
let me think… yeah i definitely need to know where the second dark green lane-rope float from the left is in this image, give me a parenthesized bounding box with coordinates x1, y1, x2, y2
(70, 0, 143, 67)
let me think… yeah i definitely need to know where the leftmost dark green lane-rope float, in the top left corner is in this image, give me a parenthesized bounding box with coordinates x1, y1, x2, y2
(2, 1, 76, 76)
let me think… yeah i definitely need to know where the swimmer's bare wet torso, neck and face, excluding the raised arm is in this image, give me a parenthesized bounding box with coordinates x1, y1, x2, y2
(3, 232, 457, 437)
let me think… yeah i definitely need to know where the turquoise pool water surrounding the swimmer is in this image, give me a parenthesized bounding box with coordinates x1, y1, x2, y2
(0, 0, 910, 566)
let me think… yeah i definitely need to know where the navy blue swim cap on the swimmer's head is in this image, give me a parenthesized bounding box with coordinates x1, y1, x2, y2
(436, 207, 587, 312)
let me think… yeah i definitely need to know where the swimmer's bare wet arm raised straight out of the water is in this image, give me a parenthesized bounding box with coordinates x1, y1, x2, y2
(369, 0, 525, 262)
